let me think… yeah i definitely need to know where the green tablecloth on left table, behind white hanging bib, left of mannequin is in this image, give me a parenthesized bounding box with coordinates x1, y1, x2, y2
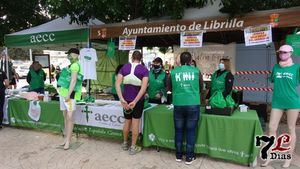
(8, 99, 64, 132)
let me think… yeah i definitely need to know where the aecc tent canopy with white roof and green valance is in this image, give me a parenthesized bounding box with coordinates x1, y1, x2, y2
(4, 15, 104, 50)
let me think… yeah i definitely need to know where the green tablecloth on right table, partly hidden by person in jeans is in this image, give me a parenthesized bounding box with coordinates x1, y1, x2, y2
(143, 105, 263, 164)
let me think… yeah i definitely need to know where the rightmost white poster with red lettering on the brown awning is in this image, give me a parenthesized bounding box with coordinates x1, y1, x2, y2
(244, 25, 272, 46)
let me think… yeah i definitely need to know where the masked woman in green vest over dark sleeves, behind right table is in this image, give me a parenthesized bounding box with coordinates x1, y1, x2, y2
(206, 59, 234, 102)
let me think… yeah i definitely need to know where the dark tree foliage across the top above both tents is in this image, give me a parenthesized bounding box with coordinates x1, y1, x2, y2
(0, 0, 300, 46)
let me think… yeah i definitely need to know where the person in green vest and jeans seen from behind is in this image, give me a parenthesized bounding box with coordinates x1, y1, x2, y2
(168, 52, 203, 164)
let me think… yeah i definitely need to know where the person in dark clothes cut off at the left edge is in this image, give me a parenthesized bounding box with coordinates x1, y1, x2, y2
(0, 70, 9, 129)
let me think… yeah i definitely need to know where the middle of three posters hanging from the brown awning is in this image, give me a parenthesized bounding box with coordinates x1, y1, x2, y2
(180, 31, 203, 48)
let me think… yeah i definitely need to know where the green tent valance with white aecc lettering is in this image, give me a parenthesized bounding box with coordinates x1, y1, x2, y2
(4, 29, 89, 47)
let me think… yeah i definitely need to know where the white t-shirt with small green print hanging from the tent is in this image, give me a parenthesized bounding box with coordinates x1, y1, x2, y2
(79, 48, 98, 80)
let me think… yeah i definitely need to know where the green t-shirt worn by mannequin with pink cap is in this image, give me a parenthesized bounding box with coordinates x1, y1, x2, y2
(270, 64, 300, 109)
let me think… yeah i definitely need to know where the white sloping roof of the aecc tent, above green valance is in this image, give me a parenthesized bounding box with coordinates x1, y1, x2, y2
(9, 15, 104, 35)
